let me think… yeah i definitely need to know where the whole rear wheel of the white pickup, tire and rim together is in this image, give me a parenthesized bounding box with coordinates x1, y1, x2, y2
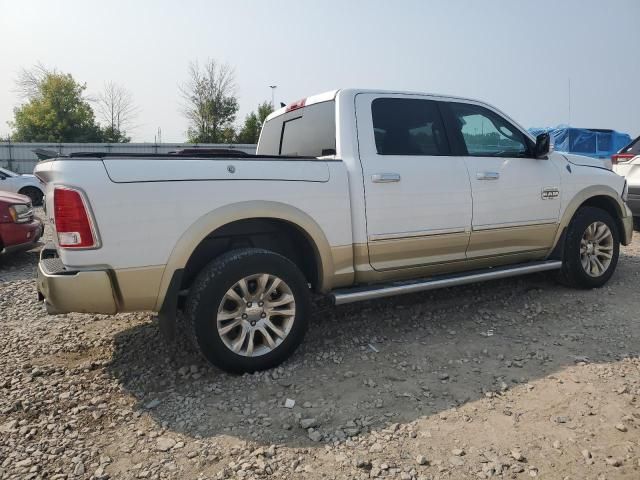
(186, 248, 311, 373)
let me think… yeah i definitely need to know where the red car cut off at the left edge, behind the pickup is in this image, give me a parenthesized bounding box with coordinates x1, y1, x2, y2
(0, 192, 43, 253)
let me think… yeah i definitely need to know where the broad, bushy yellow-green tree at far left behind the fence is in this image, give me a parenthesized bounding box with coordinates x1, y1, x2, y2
(10, 66, 102, 142)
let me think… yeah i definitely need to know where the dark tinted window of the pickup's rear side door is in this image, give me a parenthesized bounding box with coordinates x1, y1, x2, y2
(371, 98, 450, 155)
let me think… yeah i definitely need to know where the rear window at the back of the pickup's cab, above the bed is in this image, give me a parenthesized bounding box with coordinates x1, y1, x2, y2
(256, 100, 336, 157)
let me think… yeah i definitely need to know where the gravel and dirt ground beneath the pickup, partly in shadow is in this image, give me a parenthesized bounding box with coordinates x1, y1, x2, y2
(0, 215, 640, 480)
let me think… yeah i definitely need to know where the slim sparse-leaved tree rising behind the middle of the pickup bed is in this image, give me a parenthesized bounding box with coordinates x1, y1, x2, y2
(180, 60, 238, 143)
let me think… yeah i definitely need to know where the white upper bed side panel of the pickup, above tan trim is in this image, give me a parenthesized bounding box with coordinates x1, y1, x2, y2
(36, 159, 352, 269)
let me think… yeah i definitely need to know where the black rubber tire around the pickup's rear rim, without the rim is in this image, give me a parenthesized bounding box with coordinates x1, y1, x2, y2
(185, 248, 311, 373)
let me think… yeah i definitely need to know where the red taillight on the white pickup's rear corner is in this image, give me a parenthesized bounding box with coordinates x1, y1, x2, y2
(53, 187, 98, 248)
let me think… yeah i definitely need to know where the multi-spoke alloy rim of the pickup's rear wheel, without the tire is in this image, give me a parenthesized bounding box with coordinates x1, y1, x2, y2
(216, 273, 296, 357)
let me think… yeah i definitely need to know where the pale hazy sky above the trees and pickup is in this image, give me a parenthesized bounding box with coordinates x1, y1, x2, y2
(0, 0, 640, 142)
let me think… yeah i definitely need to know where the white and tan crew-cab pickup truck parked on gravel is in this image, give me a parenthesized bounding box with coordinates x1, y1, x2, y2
(35, 89, 632, 372)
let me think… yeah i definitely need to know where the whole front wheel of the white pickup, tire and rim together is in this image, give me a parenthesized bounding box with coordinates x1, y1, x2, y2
(560, 207, 620, 288)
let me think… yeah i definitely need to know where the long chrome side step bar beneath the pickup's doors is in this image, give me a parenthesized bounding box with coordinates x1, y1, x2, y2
(331, 260, 562, 305)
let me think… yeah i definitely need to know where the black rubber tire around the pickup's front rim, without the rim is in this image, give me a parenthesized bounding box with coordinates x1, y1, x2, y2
(559, 207, 620, 289)
